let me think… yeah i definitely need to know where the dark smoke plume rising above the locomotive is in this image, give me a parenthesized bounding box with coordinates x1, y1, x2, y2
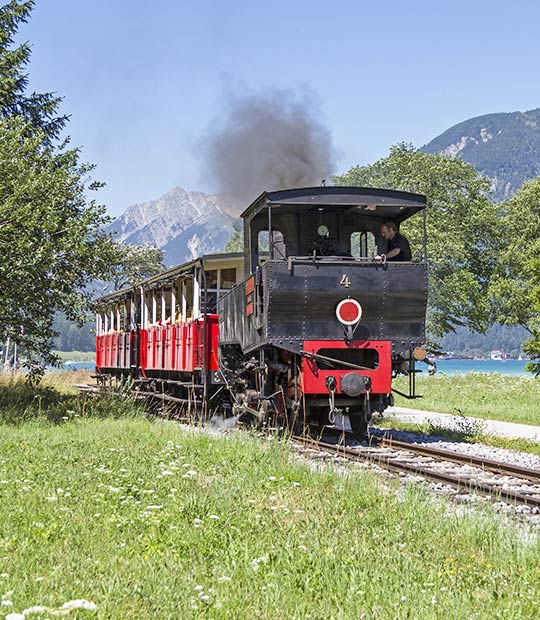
(205, 91, 335, 207)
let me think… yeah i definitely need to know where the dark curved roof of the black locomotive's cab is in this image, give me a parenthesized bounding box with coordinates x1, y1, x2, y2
(242, 185, 426, 223)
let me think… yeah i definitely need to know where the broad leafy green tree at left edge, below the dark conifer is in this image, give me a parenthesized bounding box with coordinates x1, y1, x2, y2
(0, 118, 114, 360)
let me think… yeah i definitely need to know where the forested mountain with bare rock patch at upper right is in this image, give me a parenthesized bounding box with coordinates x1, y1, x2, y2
(421, 108, 540, 201)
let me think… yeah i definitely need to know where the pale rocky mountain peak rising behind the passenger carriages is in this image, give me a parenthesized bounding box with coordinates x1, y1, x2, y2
(109, 187, 239, 266)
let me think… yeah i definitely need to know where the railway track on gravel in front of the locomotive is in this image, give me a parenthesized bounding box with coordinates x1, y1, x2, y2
(293, 431, 540, 512)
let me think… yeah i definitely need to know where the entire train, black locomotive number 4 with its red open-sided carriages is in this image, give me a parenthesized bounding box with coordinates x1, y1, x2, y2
(96, 186, 427, 435)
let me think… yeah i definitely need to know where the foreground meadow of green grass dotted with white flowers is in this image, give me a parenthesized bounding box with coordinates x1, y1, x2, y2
(0, 403, 540, 620)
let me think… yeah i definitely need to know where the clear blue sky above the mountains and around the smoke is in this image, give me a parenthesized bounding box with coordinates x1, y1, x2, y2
(19, 0, 540, 215)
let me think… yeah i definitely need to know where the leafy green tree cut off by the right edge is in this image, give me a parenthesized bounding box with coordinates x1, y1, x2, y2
(490, 177, 540, 376)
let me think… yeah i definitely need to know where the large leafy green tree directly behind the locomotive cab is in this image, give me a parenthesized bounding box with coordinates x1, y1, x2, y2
(335, 144, 497, 337)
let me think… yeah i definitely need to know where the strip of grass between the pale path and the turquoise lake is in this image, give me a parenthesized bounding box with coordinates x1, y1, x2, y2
(395, 373, 540, 425)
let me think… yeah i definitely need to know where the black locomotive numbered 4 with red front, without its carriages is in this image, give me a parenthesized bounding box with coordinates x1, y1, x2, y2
(219, 187, 427, 434)
